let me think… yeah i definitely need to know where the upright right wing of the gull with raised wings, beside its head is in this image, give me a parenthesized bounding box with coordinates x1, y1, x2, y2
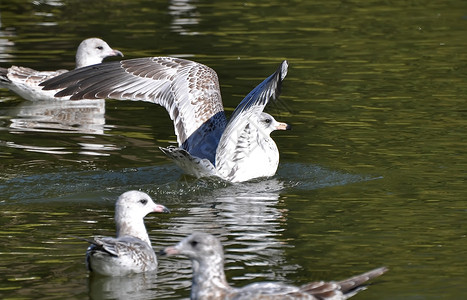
(216, 60, 288, 175)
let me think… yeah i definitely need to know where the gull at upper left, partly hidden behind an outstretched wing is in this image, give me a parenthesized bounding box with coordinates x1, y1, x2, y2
(0, 38, 123, 101)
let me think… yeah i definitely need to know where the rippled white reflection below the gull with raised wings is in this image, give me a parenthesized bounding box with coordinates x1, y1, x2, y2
(159, 178, 299, 287)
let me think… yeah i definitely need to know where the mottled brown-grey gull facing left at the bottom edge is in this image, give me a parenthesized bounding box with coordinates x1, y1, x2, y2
(160, 232, 387, 300)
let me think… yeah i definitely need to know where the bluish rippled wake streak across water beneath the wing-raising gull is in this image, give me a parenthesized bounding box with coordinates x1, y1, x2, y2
(0, 163, 381, 204)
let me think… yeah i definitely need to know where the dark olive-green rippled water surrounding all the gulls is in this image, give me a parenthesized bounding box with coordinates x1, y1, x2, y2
(0, 0, 467, 299)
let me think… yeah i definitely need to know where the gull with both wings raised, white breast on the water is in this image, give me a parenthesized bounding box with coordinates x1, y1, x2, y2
(41, 57, 290, 182)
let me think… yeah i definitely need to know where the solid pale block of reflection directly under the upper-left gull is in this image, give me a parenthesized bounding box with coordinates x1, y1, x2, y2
(10, 99, 105, 134)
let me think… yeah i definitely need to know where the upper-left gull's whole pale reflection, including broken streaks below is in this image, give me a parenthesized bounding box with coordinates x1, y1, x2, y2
(0, 99, 120, 156)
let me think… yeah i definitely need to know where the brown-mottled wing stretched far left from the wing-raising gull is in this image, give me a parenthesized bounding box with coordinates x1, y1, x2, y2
(41, 57, 226, 151)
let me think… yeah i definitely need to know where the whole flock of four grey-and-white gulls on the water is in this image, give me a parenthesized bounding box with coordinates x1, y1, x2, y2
(0, 38, 387, 300)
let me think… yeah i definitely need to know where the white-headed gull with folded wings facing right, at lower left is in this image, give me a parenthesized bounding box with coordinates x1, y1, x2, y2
(86, 191, 169, 276)
